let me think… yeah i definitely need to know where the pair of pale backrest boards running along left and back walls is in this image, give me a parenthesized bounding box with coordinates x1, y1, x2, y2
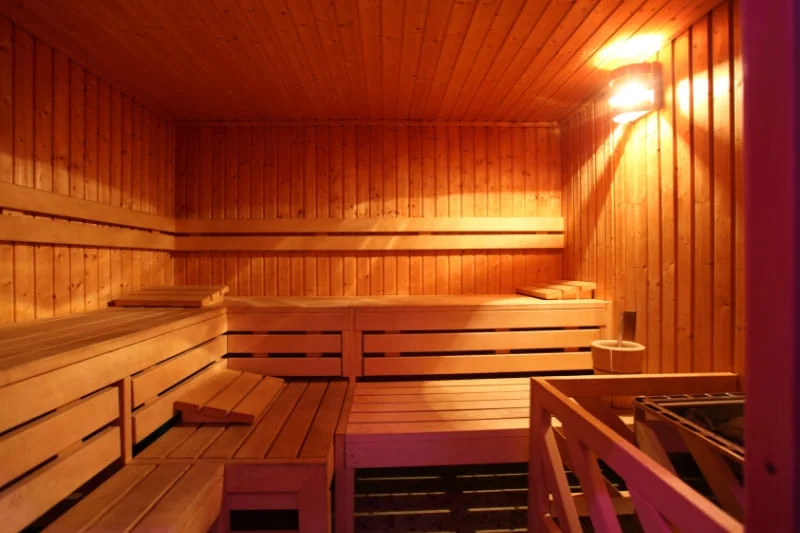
(0, 183, 564, 252)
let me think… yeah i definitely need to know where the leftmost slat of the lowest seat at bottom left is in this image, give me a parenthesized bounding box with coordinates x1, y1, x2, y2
(44, 465, 155, 533)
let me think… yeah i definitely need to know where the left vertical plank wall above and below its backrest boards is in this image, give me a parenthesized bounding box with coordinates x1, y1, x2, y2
(0, 17, 175, 324)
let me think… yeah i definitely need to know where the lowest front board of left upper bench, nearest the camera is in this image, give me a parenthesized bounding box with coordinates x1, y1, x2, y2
(0, 427, 121, 531)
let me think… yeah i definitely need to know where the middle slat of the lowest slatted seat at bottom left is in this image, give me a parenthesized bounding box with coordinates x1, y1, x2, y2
(86, 464, 191, 533)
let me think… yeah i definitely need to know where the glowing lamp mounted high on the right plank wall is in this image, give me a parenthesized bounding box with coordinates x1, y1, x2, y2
(608, 63, 662, 124)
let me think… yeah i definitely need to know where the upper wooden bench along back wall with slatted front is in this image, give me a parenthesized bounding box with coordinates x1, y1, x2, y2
(217, 294, 609, 379)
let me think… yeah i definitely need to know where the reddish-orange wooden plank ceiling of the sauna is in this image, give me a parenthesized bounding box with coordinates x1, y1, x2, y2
(0, 0, 718, 122)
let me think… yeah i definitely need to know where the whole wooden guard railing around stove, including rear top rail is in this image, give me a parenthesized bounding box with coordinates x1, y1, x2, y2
(528, 374, 744, 533)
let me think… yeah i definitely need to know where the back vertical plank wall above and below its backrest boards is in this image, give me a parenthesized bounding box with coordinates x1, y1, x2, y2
(175, 124, 562, 296)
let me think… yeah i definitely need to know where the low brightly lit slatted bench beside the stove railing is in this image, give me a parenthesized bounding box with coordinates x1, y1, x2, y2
(336, 378, 633, 532)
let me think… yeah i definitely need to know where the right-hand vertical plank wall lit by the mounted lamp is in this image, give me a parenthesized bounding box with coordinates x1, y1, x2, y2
(561, 2, 745, 372)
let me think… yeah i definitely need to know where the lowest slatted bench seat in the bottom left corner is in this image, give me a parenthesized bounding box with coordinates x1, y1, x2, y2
(45, 463, 223, 533)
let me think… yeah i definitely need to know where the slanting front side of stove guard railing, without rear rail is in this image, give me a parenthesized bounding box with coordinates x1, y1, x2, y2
(528, 376, 744, 533)
